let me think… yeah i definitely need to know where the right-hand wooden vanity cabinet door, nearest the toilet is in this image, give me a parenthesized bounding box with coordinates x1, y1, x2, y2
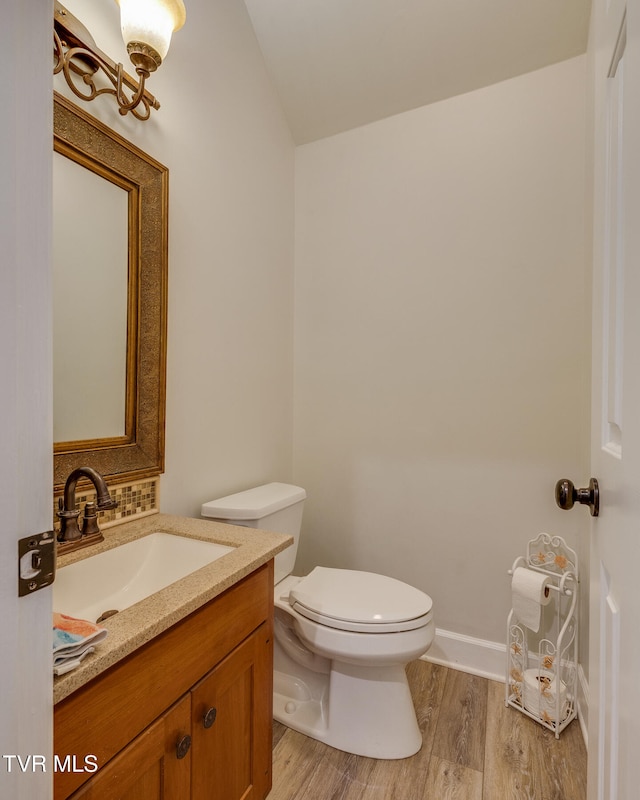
(191, 623, 273, 800)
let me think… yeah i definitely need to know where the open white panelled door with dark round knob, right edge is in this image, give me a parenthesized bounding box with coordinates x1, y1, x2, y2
(588, 0, 640, 800)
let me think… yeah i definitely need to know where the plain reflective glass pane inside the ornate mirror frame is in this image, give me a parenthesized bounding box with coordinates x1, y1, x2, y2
(53, 148, 128, 442)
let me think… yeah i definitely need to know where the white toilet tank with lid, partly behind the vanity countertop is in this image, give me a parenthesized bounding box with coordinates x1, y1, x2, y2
(200, 483, 307, 583)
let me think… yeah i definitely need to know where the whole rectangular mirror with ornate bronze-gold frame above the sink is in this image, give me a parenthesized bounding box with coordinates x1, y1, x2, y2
(54, 92, 169, 490)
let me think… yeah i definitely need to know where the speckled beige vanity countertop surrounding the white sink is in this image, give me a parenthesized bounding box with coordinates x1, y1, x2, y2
(53, 514, 293, 703)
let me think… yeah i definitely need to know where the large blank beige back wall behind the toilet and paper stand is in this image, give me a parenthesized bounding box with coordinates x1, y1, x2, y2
(294, 57, 590, 641)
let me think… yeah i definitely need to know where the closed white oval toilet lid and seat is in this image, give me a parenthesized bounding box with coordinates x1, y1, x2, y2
(289, 567, 432, 633)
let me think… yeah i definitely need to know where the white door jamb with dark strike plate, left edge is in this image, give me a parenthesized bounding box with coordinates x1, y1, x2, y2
(0, 0, 53, 800)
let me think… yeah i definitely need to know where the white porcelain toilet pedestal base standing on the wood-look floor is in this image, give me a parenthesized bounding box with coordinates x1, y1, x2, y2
(273, 643, 422, 759)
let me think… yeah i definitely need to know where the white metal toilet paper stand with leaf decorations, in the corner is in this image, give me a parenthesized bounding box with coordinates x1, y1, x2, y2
(505, 533, 578, 739)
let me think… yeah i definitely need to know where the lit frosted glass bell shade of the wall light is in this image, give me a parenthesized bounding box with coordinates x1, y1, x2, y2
(116, 0, 187, 59)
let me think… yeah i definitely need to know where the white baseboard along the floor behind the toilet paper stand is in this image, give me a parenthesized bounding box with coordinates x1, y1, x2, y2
(422, 628, 589, 745)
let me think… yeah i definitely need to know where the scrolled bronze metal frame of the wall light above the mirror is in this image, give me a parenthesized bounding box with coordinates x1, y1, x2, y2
(53, 0, 160, 120)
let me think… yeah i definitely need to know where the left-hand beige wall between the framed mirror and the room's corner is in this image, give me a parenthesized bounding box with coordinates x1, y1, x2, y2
(56, 0, 294, 515)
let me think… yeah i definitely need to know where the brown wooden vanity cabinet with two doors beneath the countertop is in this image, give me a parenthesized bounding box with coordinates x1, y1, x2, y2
(54, 562, 273, 800)
